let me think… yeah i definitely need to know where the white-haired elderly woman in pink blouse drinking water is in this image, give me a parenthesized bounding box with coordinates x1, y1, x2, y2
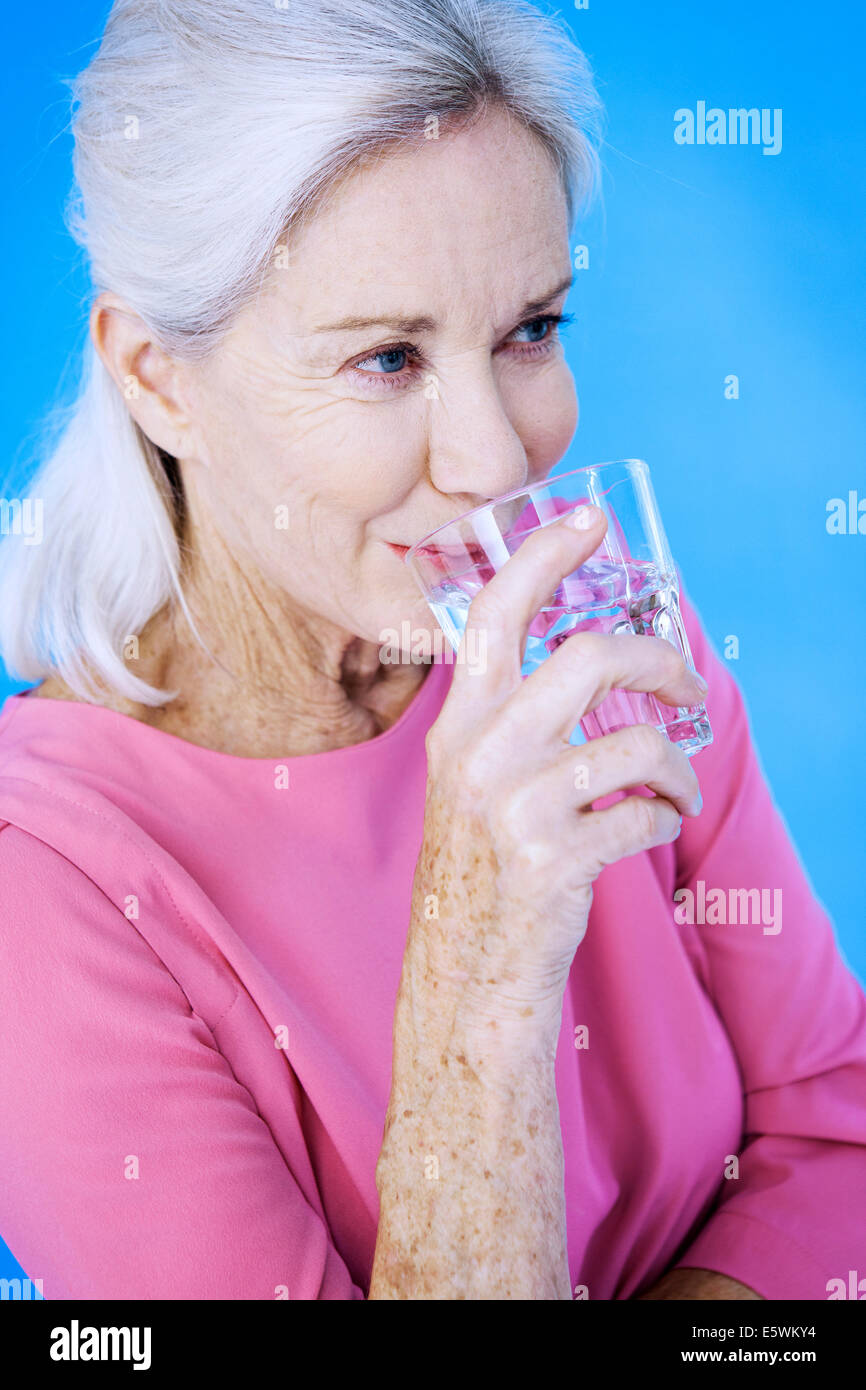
(0, 0, 866, 1300)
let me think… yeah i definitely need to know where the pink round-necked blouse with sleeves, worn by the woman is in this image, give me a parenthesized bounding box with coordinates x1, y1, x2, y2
(0, 586, 866, 1300)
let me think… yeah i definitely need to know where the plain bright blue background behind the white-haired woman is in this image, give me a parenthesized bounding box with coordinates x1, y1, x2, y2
(0, 0, 866, 1277)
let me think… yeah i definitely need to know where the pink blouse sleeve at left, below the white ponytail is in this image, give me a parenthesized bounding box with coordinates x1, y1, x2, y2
(0, 821, 364, 1300)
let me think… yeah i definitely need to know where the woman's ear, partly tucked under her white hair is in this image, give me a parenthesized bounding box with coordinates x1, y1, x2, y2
(90, 293, 199, 459)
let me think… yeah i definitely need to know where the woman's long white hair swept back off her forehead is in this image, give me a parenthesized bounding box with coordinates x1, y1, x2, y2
(0, 0, 603, 705)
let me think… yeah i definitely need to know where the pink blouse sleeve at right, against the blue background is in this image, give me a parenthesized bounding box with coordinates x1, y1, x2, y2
(664, 581, 866, 1300)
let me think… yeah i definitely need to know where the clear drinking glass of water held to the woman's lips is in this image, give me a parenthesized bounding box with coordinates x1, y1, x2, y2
(405, 459, 713, 756)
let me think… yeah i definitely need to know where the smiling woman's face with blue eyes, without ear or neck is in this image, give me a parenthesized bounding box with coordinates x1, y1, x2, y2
(183, 108, 578, 642)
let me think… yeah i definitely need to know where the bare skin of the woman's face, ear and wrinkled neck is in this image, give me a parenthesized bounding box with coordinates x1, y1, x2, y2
(42, 107, 578, 758)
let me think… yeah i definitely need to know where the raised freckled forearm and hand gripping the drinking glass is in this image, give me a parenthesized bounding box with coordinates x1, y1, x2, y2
(368, 513, 702, 1300)
